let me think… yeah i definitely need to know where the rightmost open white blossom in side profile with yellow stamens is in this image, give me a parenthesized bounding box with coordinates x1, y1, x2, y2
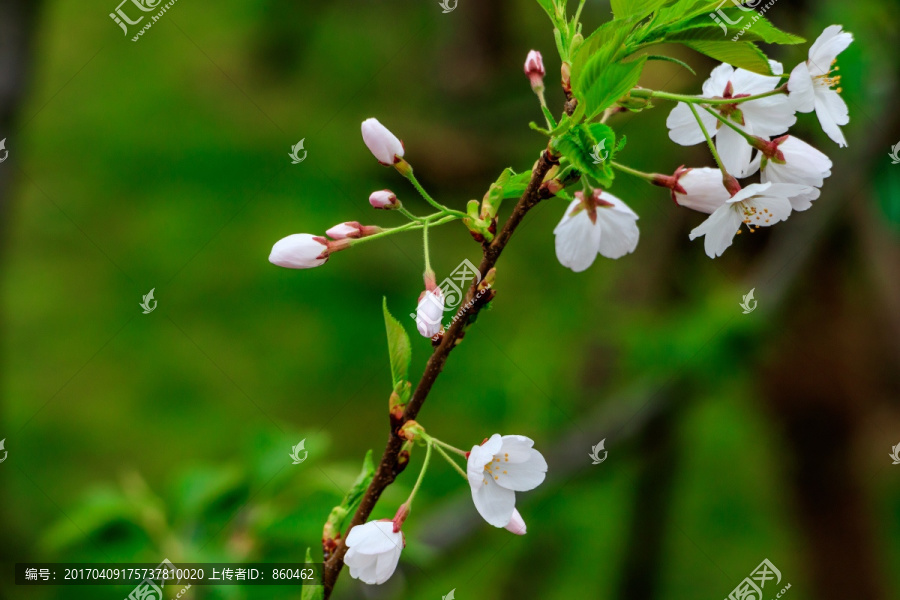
(788, 25, 853, 148)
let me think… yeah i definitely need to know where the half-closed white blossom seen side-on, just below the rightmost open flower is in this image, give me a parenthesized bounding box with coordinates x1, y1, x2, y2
(760, 135, 831, 210)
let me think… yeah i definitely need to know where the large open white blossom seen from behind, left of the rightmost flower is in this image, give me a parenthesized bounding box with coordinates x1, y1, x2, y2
(666, 61, 797, 177)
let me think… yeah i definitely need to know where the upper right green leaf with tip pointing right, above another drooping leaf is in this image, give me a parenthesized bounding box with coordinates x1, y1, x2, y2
(665, 8, 805, 44)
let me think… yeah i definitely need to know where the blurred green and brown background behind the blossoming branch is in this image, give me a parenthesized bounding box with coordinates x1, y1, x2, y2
(0, 0, 900, 600)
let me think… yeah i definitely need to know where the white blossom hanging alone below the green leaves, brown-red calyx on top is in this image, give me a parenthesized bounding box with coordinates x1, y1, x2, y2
(553, 190, 640, 273)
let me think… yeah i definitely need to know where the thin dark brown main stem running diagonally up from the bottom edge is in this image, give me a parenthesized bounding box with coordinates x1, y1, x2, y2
(322, 146, 559, 600)
